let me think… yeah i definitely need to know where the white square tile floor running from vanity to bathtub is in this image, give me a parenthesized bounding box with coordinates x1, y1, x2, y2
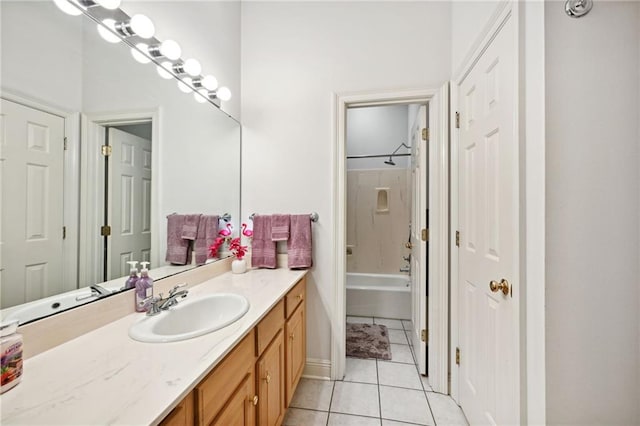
(284, 317, 467, 426)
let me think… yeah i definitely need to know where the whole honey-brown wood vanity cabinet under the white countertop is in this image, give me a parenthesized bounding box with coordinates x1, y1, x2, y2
(161, 277, 307, 426)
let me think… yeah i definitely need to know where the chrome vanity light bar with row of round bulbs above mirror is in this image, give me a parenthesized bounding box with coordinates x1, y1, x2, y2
(53, 0, 231, 108)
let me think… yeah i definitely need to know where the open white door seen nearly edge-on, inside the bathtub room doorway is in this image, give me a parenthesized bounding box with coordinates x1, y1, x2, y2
(411, 106, 429, 375)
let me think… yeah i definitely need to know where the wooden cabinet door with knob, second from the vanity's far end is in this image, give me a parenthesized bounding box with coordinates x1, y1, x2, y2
(256, 329, 285, 426)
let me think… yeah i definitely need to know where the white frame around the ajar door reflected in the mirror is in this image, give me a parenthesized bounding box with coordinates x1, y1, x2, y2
(79, 109, 162, 283)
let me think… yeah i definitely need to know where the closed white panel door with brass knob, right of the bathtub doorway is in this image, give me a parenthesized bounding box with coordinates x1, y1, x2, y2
(458, 17, 520, 425)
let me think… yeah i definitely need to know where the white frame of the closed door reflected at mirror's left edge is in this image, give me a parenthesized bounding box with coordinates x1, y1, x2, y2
(1, 91, 80, 291)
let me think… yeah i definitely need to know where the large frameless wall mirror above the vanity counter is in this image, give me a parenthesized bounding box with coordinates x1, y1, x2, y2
(0, 1, 241, 323)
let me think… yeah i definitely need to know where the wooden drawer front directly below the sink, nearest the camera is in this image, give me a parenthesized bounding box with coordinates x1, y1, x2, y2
(196, 330, 255, 425)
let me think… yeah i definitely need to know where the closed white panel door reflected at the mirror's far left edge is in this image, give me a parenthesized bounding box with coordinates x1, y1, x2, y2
(0, 99, 64, 307)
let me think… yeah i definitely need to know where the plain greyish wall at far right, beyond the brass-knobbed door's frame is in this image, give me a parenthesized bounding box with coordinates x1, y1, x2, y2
(545, 2, 640, 425)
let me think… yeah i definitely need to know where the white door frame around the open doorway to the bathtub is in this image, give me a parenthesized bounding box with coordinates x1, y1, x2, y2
(331, 87, 449, 393)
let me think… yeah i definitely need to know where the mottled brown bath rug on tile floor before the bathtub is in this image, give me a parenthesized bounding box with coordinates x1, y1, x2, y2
(346, 322, 391, 361)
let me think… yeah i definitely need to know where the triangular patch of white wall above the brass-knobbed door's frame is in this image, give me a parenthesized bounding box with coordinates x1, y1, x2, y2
(451, 1, 500, 77)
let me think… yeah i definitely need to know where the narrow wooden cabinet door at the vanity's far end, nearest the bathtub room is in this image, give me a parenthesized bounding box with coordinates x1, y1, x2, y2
(285, 303, 307, 407)
